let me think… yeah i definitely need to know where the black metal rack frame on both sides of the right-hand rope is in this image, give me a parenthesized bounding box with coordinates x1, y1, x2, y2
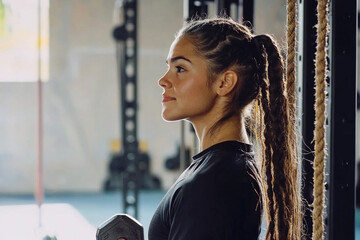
(299, 0, 357, 240)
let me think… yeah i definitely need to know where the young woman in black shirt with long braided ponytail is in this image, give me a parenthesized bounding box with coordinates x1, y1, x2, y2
(149, 18, 301, 240)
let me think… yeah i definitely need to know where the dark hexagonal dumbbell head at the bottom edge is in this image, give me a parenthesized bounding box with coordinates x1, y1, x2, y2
(96, 214, 144, 240)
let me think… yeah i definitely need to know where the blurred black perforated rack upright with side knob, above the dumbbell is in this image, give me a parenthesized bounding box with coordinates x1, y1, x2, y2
(114, 0, 140, 218)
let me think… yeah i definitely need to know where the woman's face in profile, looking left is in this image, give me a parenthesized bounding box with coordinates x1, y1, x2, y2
(159, 36, 216, 122)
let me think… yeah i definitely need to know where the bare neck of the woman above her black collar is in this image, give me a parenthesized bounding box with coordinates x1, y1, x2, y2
(192, 116, 249, 151)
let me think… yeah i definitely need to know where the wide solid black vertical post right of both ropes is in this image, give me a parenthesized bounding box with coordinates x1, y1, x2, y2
(329, 0, 357, 240)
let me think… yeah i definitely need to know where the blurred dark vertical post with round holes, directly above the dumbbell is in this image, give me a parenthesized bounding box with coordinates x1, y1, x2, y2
(122, 0, 139, 218)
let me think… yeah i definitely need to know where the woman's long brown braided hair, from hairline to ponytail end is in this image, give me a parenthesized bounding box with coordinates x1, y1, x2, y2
(178, 18, 301, 240)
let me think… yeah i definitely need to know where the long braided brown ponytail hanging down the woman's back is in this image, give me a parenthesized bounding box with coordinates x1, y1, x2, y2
(254, 35, 301, 239)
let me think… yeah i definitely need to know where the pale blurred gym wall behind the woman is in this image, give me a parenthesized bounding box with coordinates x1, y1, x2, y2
(0, 0, 324, 193)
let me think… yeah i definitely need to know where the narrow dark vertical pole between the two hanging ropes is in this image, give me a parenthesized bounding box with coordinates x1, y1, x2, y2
(299, 1, 317, 237)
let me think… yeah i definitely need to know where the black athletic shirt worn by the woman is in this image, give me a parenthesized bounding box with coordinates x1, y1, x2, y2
(149, 141, 262, 240)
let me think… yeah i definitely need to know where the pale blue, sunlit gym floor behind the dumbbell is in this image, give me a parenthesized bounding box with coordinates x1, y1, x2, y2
(0, 191, 360, 240)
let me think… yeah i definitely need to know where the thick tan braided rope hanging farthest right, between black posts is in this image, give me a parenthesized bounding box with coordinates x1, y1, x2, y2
(313, 0, 329, 240)
